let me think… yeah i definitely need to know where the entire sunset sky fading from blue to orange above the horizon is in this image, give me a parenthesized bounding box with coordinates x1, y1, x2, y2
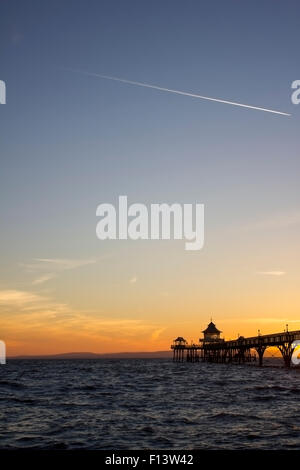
(0, 0, 300, 355)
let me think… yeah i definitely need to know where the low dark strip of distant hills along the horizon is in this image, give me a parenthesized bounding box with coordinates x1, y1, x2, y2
(7, 351, 172, 359)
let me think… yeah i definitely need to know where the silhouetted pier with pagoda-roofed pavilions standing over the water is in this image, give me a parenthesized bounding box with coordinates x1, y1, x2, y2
(171, 322, 300, 367)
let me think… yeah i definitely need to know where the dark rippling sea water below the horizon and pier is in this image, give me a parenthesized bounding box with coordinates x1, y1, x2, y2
(0, 359, 300, 450)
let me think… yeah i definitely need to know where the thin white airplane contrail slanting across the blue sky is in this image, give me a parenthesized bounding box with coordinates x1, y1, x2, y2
(64, 68, 291, 116)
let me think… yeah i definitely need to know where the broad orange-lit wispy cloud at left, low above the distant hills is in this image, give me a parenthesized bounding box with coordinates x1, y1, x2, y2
(0, 289, 163, 342)
